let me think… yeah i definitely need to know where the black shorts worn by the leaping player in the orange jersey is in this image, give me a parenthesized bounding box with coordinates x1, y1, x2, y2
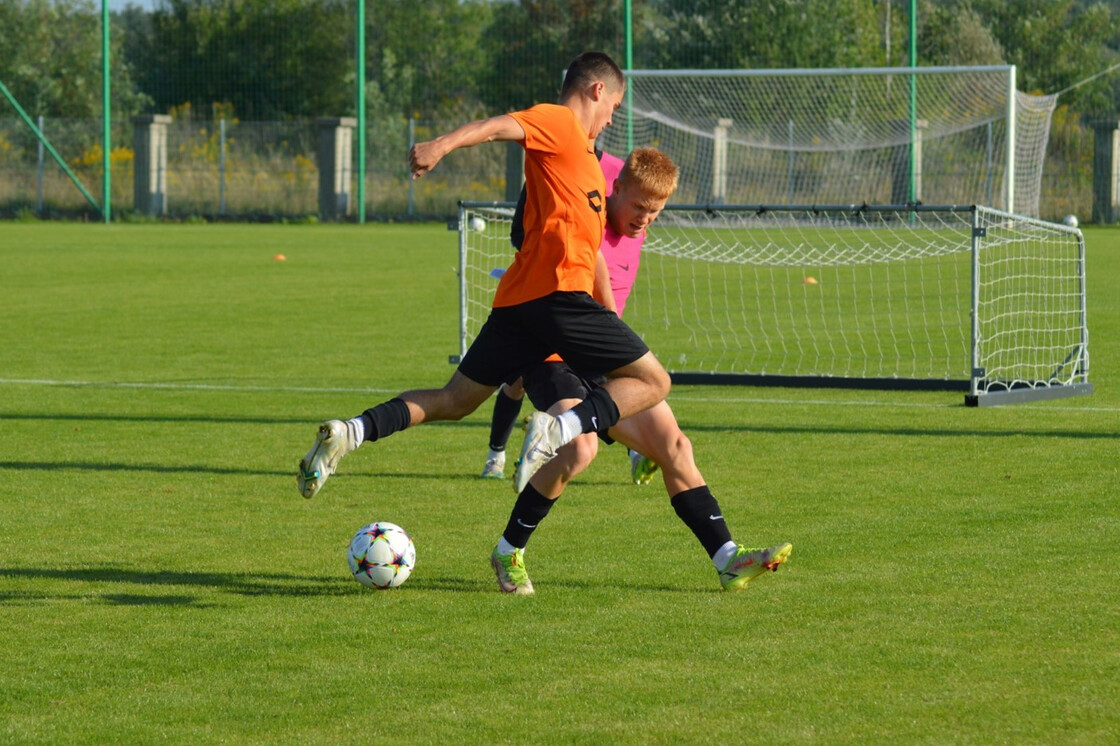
(459, 292, 650, 386)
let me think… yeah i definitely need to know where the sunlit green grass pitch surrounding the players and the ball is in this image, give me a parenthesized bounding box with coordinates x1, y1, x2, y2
(0, 224, 1120, 745)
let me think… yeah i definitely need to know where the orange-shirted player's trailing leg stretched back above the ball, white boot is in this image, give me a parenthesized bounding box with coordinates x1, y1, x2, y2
(296, 371, 496, 498)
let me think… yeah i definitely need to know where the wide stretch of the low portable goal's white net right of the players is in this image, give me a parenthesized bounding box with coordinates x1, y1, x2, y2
(626, 207, 971, 388)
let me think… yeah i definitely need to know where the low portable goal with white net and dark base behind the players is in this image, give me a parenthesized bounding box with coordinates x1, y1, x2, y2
(458, 203, 1092, 404)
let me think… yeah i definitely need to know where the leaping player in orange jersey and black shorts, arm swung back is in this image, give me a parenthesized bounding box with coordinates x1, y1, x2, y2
(297, 52, 670, 497)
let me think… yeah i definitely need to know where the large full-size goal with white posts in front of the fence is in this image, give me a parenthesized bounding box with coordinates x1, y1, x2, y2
(598, 66, 1057, 216)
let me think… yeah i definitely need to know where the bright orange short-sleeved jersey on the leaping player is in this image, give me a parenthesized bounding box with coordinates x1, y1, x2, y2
(494, 104, 607, 307)
